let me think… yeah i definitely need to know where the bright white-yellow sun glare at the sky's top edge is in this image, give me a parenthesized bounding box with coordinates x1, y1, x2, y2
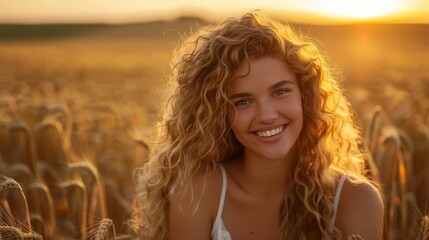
(321, 0, 398, 19)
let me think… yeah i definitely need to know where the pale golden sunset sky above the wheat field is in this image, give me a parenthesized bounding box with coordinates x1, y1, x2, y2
(0, 0, 429, 24)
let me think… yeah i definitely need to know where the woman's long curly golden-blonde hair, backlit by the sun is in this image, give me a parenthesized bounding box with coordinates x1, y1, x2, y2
(130, 12, 365, 239)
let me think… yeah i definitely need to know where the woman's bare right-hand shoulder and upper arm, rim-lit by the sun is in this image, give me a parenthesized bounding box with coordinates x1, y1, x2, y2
(335, 177, 384, 240)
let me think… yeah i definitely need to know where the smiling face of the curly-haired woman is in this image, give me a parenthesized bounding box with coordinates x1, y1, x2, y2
(227, 56, 303, 160)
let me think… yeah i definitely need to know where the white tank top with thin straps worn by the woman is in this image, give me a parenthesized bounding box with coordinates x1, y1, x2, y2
(212, 165, 347, 240)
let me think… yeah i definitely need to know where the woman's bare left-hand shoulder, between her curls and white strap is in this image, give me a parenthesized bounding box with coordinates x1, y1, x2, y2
(169, 168, 222, 240)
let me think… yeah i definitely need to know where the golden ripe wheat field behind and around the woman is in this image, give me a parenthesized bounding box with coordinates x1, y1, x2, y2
(0, 18, 429, 239)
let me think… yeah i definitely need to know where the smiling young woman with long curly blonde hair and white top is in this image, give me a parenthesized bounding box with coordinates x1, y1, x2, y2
(131, 13, 383, 240)
